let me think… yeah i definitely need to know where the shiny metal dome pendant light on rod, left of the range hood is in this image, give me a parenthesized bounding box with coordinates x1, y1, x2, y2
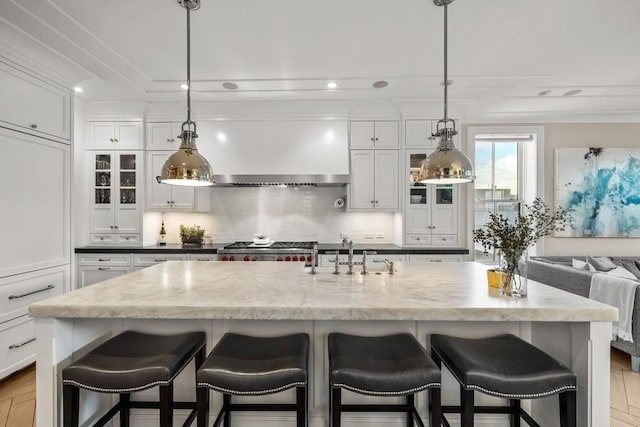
(158, 0, 214, 187)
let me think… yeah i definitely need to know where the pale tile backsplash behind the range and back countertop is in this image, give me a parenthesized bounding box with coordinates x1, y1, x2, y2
(143, 187, 399, 244)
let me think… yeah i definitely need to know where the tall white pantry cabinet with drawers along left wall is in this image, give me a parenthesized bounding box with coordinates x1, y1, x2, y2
(0, 56, 72, 378)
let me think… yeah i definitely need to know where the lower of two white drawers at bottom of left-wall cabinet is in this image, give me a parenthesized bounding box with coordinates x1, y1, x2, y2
(0, 316, 36, 378)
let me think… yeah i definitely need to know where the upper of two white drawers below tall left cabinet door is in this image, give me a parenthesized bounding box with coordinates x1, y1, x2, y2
(0, 266, 69, 322)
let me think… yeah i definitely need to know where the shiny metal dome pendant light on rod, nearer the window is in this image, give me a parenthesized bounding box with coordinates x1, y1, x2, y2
(419, 0, 475, 184)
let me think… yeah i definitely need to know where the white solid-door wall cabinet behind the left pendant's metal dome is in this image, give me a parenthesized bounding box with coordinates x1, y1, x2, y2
(145, 151, 196, 210)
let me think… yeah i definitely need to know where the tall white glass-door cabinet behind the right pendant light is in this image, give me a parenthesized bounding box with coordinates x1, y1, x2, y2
(404, 150, 460, 246)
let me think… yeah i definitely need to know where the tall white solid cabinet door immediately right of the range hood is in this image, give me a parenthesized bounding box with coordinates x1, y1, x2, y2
(348, 150, 375, 209)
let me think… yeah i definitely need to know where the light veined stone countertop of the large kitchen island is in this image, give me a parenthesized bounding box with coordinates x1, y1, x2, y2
(29, 261, 618, 322)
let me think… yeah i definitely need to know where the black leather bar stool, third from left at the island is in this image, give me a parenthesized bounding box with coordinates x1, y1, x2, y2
(328, 332, 441, 427)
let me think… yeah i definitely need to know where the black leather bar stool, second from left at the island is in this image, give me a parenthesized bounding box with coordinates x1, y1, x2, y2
(196, 332, 309, 427)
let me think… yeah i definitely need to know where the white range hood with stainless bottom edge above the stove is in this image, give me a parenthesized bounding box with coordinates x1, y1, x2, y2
(198, 120, 349, 187)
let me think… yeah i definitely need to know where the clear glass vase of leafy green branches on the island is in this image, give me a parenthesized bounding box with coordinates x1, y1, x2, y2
(473, 197, 569, 298)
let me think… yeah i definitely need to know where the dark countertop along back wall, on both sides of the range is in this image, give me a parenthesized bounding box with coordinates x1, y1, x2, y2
(75, 243, 469, 255)
